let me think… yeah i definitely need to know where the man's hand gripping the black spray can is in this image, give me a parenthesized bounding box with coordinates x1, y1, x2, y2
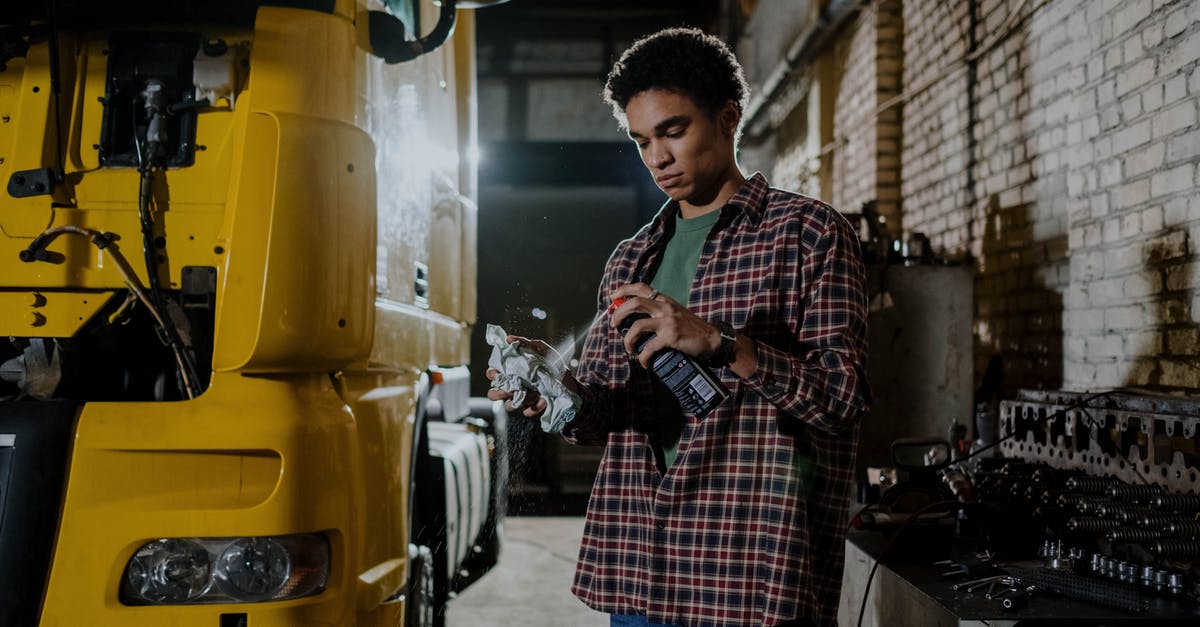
(611, 283, 721, 369)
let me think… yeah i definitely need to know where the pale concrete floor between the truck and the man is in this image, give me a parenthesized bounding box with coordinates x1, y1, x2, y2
(446, 516, 608, 627)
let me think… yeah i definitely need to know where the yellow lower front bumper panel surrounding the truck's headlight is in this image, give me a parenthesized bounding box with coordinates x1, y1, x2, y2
(40, 374, 372, 627)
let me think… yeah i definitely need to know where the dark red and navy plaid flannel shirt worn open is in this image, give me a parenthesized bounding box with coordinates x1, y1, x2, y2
(564, 174, 870, 627)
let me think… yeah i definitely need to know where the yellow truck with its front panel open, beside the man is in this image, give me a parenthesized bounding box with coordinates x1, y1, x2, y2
(0, 0, 505, 627)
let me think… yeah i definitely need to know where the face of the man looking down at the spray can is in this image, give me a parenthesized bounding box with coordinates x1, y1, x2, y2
(625, 89, 737, 202)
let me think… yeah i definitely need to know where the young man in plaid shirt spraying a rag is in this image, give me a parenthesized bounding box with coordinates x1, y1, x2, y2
(488, 29, 869, 627)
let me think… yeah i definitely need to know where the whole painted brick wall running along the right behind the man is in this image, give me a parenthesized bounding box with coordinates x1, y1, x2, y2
(744, 0, 1200, 392)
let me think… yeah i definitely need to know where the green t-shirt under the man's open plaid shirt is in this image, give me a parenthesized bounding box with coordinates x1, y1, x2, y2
(650, 210, 721, 468)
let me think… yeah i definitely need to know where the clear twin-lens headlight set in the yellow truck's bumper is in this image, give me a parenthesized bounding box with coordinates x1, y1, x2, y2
(120, 533, 330, 605)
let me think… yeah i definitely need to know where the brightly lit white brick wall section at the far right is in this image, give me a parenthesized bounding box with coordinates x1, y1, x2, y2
(1064, 0, 1200, 390)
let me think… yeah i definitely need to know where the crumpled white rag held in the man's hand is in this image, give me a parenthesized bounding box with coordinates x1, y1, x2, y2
(486, 324, 582, 434)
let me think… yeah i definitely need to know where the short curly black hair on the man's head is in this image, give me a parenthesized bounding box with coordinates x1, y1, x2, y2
(604, 28, 750, 129)
